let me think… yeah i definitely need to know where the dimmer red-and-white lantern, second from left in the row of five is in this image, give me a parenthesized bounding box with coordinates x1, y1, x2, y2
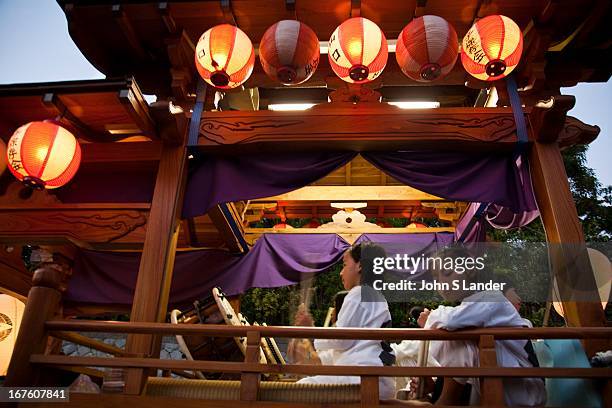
(259, 20, 320, 85)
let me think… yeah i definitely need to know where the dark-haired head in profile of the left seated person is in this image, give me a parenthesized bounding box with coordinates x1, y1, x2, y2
(340, 242, 386, 290)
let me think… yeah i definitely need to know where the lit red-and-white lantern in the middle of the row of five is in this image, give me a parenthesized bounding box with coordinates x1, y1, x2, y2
(328, 17, 389, 84)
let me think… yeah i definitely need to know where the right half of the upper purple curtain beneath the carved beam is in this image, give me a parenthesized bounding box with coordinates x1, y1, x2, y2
(362, 151, 537, 212)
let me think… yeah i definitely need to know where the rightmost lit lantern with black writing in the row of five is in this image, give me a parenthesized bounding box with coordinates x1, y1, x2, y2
(461, 15, 523, 81)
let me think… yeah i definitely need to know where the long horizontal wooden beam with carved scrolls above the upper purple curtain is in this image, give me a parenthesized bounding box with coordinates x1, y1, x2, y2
(200, 111, 516, 145)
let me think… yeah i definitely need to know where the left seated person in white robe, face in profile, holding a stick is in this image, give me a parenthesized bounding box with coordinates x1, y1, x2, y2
(296, 243, 395, 399)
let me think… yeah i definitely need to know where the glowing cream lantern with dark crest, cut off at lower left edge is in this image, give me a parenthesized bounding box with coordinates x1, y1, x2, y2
(0, 294, 25, 375)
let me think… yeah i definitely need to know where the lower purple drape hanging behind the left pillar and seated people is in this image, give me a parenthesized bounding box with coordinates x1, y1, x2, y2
(65, 233, 453, 307)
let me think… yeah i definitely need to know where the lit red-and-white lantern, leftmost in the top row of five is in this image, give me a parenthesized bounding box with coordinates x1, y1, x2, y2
(195, 24, 255, 89)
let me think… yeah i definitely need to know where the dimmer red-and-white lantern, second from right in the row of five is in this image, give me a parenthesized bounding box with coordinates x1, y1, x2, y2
(395, 16, 459, 82)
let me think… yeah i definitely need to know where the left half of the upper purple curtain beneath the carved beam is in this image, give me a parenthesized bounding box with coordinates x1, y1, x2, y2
(183, 152, 357, 218)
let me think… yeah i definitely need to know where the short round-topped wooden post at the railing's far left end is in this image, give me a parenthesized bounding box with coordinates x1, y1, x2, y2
(4, 265, 64, 387)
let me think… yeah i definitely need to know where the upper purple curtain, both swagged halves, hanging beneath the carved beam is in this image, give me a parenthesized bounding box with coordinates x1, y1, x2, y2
(183, 151, 537, 217)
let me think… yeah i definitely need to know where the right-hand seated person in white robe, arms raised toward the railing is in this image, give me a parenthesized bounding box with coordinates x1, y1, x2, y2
(419, 249, 546, 406)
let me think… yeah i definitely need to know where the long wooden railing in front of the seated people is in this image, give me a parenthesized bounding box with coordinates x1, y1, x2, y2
(23, 320, 612, 407)
